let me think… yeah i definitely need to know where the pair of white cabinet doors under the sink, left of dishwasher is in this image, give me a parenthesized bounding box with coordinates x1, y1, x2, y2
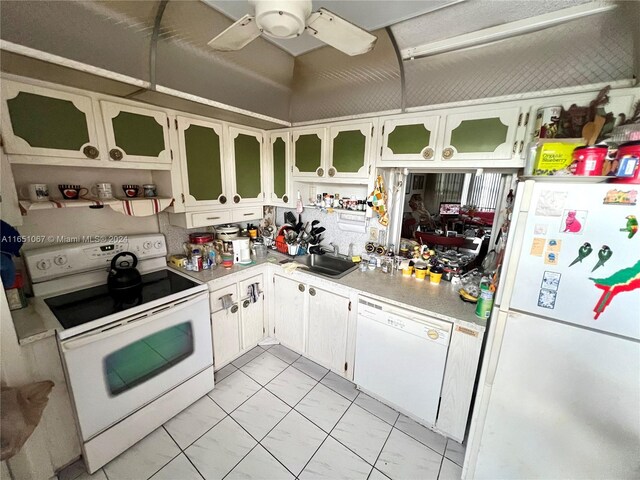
(273, 275, 351, 375)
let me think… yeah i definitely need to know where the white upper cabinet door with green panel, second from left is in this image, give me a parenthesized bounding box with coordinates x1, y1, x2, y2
(100, 101, 172, 163)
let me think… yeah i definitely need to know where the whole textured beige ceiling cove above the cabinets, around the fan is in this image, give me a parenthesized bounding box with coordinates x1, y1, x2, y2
(0, 0, 640, 126)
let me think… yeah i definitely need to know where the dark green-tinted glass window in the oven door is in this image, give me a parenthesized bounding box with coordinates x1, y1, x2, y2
(104, 322, 194, 395)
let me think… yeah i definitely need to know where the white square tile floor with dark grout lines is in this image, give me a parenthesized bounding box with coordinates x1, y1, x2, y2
(59, 345, 464, 480)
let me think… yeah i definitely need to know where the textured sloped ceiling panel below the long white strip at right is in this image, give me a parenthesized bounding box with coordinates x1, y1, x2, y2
(404, 9, 637, 107)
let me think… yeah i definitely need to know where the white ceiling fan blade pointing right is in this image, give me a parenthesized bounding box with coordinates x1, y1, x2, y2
(307, 8, 378, 56)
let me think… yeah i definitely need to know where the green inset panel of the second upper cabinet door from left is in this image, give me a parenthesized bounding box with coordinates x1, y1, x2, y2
(111, 112, 166, 157)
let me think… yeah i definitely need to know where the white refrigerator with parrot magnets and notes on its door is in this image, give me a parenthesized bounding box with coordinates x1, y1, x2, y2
(463, 179, 640, 480)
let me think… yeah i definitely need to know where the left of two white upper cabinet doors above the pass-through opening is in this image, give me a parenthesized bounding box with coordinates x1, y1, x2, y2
(378, 114, 440, 167)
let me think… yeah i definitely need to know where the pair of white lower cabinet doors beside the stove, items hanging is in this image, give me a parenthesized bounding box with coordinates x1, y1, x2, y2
(209, 273, 265, 370)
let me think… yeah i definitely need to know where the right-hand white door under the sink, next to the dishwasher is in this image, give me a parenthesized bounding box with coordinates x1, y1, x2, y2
(306, 286, 351, 371)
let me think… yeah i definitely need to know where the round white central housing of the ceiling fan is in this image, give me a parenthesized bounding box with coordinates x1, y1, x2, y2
(249, 0, 311, 39)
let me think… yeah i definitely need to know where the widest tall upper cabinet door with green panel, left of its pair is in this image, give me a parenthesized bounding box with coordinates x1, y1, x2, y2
(176, 116, 229, 208)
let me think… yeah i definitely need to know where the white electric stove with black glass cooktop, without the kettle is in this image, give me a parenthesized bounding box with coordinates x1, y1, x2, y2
(24, 234, 214, 473)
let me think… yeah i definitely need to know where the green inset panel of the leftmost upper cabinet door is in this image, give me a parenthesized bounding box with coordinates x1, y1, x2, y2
(7, 92, 89, 151)
